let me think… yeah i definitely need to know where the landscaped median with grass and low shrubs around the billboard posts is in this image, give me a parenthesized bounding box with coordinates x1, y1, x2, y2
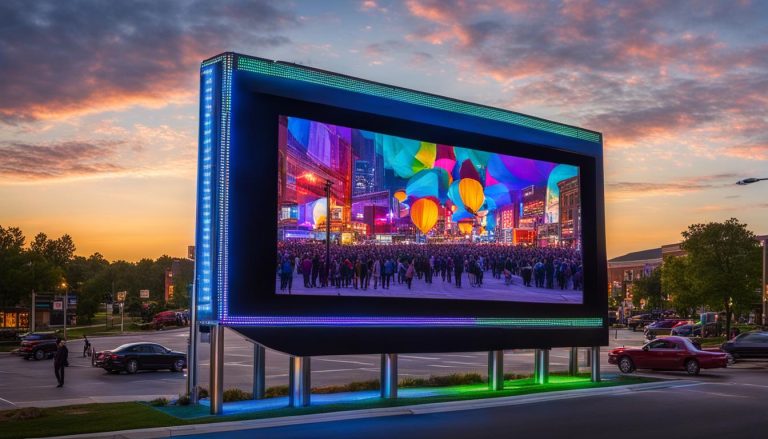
(0, 375, 658, 438)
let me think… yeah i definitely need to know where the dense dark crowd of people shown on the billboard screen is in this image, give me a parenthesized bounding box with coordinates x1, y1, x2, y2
(276, 241, 583, 293)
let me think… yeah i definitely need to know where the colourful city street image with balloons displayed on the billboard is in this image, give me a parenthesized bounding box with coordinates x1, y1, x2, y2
(275, 116, 584, 304)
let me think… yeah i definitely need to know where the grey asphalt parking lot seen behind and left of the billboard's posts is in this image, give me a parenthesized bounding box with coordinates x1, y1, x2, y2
(0, 329, 642, 409)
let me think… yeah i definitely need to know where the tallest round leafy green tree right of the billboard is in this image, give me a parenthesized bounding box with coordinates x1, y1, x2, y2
(681, 218, 760, 334)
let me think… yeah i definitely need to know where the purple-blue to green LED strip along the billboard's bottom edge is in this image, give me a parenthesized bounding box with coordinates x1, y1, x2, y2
(213, 316, 603, 329)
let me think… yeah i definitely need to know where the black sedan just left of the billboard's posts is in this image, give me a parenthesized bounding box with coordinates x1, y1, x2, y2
(94, 343, 187, 374)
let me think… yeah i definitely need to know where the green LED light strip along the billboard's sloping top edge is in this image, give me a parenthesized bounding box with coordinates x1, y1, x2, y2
(234, 55, 602, 143)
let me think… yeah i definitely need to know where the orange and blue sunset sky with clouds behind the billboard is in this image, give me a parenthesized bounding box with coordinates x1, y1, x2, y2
(0, 0, 768, 261)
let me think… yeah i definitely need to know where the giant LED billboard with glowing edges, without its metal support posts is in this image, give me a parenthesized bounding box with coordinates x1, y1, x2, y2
(195, 53, 608, 355)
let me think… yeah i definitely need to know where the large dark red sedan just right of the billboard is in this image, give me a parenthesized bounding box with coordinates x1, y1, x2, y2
(608, 337, 728, 375)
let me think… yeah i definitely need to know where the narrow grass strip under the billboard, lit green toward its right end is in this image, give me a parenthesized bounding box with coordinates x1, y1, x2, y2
(0, 374, 656, 439)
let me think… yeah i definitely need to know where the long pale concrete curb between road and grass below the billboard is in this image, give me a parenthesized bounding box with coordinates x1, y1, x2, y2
(46, 380, 688, 439)
